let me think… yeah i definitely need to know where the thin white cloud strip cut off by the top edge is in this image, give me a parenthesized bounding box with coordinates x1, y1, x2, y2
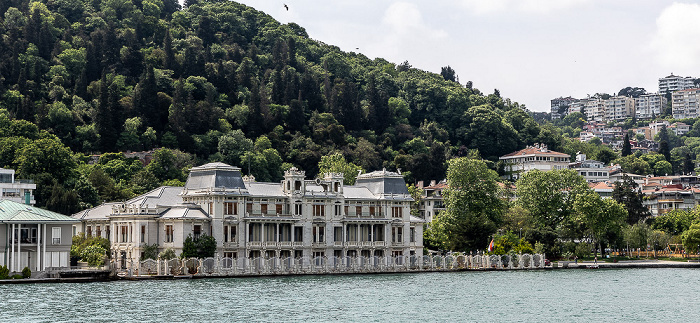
(461, 0, 589, 15)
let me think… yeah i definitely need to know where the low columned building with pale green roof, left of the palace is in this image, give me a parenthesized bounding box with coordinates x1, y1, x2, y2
(0, 200, 80, 272)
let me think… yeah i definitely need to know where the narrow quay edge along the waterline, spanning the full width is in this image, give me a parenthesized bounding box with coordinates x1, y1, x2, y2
(0, 260, 700, 285)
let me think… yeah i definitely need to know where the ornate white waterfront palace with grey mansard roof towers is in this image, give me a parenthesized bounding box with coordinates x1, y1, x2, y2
(73, 163, 424, 266)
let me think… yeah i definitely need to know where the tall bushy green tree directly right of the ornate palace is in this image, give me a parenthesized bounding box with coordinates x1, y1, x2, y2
(428, 157, 506, 251)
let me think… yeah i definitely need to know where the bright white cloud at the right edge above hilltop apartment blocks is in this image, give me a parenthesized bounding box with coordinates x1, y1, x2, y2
(651, 3, 700, 68)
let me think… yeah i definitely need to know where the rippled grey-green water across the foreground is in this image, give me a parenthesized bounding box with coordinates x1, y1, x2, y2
(0, 269, 700, 322)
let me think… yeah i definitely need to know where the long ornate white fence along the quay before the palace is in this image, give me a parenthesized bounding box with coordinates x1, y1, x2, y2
(119, 254, 545, 276)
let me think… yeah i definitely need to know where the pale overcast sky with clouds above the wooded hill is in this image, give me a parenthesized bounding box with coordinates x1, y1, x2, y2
(228, 0, 700, 111)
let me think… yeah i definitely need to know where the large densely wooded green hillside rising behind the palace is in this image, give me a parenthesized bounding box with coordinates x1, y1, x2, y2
(0, 0, 565, 213)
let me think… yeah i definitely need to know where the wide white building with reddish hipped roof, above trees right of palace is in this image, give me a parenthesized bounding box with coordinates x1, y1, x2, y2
(498, 144, 571, 180)
